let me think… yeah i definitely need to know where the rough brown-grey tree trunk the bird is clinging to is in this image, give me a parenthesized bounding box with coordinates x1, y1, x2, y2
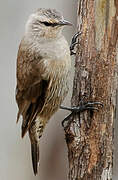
(65, 0, 118, 180)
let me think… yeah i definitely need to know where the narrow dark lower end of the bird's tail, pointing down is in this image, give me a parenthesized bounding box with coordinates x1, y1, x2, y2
(31, 142, 39, 176)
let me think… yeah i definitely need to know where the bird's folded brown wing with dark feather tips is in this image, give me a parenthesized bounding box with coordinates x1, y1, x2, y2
(16, 39, 49, 137)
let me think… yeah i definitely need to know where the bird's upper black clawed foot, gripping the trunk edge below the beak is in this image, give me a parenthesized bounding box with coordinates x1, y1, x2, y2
(70, 32, 81, 55)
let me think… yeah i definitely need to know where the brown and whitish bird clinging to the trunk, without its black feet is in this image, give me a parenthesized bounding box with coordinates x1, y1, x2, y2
(16, 8, 72, 175)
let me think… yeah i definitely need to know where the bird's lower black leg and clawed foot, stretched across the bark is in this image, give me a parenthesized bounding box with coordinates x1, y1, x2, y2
(60, 102, 103, 127)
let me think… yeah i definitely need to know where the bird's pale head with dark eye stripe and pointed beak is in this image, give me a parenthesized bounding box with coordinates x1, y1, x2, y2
(26, 8, 72, 38)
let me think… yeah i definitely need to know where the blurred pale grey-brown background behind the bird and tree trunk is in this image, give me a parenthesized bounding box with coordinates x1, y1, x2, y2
(0, 0, 118, 180)
